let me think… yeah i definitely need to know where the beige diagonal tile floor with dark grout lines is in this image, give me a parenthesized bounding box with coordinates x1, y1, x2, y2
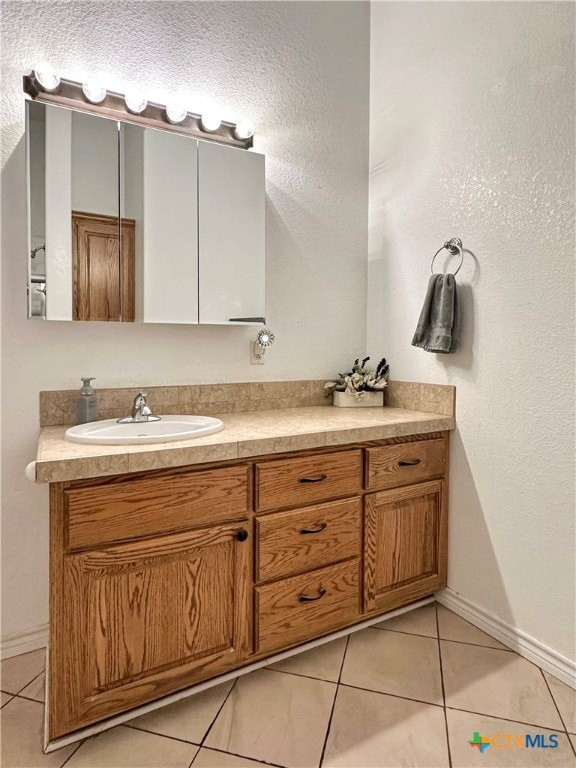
(0, 605, 576, 768)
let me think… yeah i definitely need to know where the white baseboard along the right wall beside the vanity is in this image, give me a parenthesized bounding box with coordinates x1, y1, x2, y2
(436, 587, 576, 688)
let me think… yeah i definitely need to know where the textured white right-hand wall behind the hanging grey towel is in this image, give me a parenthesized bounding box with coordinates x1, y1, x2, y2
(368, 2, 576, 659)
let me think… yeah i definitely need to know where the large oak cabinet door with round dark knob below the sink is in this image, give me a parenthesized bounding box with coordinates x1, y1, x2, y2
(49, 524, 251, 739)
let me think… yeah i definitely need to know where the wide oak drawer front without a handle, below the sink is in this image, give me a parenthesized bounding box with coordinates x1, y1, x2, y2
(65, 464, 250, 550)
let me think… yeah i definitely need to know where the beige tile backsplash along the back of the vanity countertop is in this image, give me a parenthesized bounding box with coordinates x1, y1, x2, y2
(40, 379, 455, 427)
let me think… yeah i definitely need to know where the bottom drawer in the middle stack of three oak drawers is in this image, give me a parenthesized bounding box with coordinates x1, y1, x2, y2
(256, 559, 360, 653)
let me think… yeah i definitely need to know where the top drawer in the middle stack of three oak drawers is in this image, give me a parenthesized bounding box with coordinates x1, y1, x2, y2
(256, 450, 362, 512)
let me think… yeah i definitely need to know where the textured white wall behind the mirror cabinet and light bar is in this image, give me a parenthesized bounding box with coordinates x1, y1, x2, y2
(0, 0, 370, 636)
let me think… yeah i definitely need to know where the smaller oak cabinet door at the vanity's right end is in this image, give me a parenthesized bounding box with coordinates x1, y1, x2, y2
(364, 480, 446, 611)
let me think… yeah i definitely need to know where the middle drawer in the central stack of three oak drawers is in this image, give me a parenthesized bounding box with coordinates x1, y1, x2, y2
(256, 499, 362, 581)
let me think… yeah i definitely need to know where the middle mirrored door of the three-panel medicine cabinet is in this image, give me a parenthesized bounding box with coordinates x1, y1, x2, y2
(120, 123, 198, 324)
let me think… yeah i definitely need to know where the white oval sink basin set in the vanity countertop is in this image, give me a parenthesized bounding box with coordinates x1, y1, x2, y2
(65, 416, 224, 445)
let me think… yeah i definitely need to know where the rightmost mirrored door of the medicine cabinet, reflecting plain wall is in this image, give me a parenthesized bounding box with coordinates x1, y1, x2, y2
(198, 141, 265, 324)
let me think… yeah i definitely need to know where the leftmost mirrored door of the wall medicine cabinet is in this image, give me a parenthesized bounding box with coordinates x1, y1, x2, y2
(27, 102, 123, 321)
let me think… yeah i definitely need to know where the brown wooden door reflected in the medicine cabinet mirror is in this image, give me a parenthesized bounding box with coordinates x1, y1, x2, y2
(72, 211, 136, 322)
